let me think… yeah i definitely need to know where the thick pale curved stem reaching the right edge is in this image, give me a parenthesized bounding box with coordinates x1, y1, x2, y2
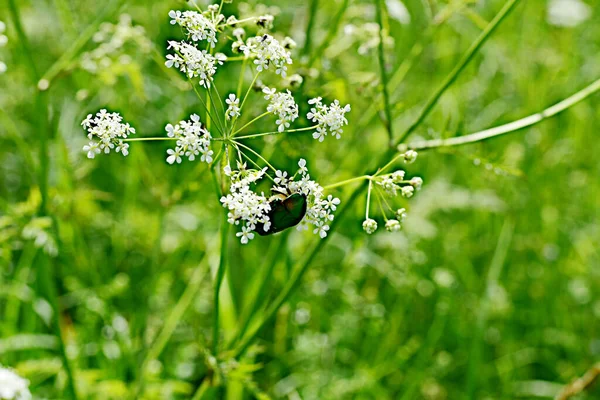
(408, 79, 600, 150)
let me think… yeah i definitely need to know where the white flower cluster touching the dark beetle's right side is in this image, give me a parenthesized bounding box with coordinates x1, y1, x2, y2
(284, 158, 340, 238)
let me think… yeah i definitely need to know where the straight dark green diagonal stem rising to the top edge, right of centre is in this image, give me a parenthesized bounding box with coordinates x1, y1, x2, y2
(395, 0, 519, 144)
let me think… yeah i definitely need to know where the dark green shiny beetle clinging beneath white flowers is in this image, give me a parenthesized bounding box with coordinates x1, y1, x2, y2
(256, 193, 306, 236)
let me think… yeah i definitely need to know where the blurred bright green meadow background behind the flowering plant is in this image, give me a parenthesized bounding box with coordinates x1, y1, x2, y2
(0, 0, 600, 400)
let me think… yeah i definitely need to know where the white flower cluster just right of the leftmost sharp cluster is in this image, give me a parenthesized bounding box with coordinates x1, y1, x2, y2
(165, 114, 213, 164)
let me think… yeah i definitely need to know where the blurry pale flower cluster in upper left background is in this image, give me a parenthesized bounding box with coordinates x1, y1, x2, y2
(80, 14, 152, 76)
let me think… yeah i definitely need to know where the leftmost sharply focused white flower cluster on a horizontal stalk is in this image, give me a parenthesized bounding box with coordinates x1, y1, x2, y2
(81, 109, 135, 158)
